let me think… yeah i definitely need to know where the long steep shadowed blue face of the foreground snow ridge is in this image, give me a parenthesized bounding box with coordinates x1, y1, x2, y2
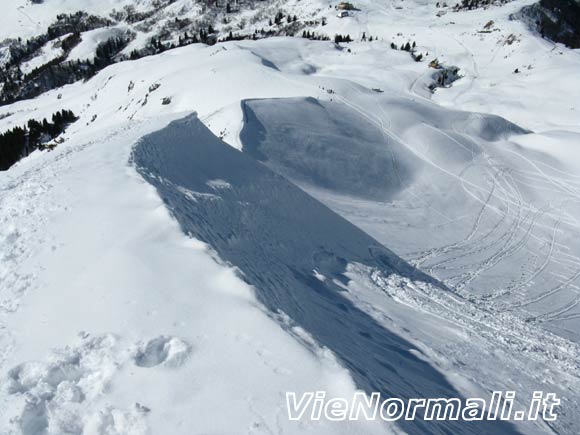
(132, 116, 516, 434)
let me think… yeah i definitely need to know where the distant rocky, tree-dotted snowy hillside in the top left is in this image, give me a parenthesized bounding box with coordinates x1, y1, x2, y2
(0, 0, 305, 105)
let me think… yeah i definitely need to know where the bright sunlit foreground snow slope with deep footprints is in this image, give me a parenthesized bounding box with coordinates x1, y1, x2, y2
(0, 113, 396, 434)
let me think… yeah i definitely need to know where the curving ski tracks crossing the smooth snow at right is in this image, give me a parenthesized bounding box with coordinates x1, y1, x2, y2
(314, 87, 580, 334)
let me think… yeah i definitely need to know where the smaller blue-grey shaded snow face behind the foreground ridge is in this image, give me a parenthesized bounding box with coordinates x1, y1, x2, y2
(240, 98, 420, 200)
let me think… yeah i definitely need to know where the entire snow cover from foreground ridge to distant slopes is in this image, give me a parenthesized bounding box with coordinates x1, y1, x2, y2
(0, 0, 580, 435)
